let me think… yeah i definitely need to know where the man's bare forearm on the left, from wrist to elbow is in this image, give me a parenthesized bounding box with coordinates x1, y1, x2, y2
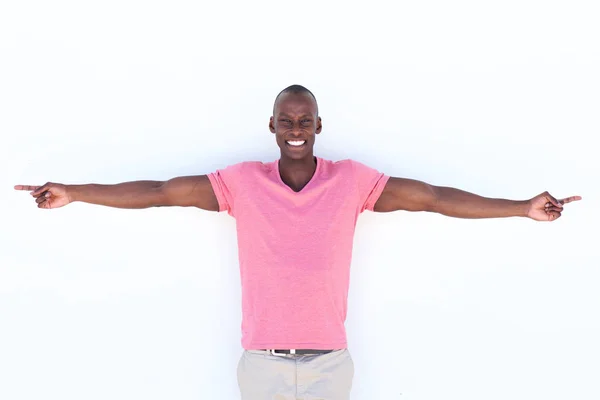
(67, 181, 163, 208)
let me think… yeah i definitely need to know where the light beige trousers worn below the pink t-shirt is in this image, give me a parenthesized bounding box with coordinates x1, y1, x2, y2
(237, 349, 354, 400)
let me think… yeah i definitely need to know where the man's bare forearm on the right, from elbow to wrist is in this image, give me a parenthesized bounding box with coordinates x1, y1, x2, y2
(432, 186, 529, 218)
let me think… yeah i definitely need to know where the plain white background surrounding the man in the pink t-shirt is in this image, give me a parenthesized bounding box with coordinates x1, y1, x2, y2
(0, 0, 600, 400)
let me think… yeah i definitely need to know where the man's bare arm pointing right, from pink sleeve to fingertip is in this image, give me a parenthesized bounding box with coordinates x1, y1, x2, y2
(374, 177, 581, 221)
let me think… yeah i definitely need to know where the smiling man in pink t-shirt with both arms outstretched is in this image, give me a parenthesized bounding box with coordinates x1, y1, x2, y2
(15, 85, 581, 400)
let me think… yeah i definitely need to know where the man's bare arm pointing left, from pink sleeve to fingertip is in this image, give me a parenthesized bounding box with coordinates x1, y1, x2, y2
(15, 175, 219, 211)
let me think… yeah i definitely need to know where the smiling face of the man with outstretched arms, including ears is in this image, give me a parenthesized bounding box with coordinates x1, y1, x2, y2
(269, 93, 322, 160)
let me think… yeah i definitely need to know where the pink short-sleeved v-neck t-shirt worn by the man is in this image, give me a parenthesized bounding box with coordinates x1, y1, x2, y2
(208, 157, 389, 350)
